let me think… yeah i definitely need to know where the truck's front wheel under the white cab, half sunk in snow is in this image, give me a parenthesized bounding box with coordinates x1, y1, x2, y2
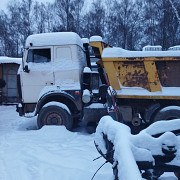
(37, 105, 73, 130)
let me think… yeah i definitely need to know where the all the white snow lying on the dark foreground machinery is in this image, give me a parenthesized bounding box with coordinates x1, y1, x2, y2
(95, 116, 180, 180)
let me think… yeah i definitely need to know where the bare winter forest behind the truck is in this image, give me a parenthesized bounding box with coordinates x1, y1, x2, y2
(0, 0, 180, 57)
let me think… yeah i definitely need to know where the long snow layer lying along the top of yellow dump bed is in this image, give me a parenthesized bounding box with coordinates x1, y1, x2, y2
(102, 47, 180, 58)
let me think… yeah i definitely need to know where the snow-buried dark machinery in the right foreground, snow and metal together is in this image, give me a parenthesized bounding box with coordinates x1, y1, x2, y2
(95, 116, 180, 180)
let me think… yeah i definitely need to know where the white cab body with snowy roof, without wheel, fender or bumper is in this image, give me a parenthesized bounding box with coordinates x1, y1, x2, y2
(20, 32, 86, 103)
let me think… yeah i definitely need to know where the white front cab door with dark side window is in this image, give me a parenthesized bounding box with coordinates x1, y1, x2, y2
(21, 47, 54, 103)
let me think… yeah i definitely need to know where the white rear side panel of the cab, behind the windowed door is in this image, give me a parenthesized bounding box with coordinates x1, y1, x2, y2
(54, 45, 82, 90)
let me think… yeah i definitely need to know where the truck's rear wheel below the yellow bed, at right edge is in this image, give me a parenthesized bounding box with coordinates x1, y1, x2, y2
(153, 106, 180, 122)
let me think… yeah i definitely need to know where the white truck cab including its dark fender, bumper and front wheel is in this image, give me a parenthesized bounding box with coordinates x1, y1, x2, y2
(17, 32, 106, 129)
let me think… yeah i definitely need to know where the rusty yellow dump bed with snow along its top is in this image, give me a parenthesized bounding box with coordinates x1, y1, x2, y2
(90, 39, 180, 99)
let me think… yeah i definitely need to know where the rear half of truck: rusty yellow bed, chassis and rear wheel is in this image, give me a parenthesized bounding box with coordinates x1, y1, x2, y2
(90, 38, 180, 131)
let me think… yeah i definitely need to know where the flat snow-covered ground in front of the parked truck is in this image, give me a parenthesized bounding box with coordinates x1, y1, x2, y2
(0, 106, 177, 180)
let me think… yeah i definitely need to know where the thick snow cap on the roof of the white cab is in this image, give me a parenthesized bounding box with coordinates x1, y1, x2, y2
(26, 32, 83, 48)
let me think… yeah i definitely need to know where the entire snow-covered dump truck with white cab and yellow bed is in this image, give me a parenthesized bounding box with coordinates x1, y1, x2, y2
(17, 32, 180, 132)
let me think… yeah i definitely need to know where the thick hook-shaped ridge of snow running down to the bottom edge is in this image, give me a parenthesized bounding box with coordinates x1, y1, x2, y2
(95, 116, 142, 180)
